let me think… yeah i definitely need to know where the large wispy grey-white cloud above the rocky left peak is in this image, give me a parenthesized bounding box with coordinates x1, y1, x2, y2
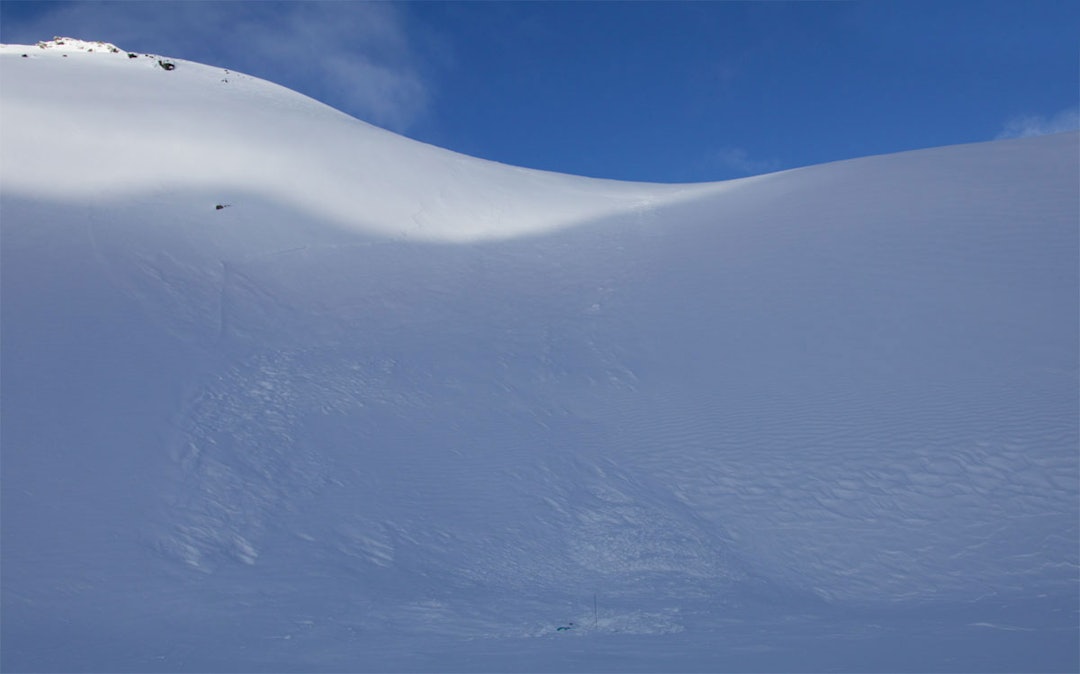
(3, 1, 430, 131)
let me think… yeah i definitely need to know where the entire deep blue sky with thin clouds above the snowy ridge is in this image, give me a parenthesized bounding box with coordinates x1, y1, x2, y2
(0, 0, 1080, 181)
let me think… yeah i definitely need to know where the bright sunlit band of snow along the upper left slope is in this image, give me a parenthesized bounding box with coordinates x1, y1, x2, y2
(0, 43, 727, 243)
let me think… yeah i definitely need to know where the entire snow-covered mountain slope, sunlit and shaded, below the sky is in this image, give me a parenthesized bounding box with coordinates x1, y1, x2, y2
(0, 39, 1080, 672)
